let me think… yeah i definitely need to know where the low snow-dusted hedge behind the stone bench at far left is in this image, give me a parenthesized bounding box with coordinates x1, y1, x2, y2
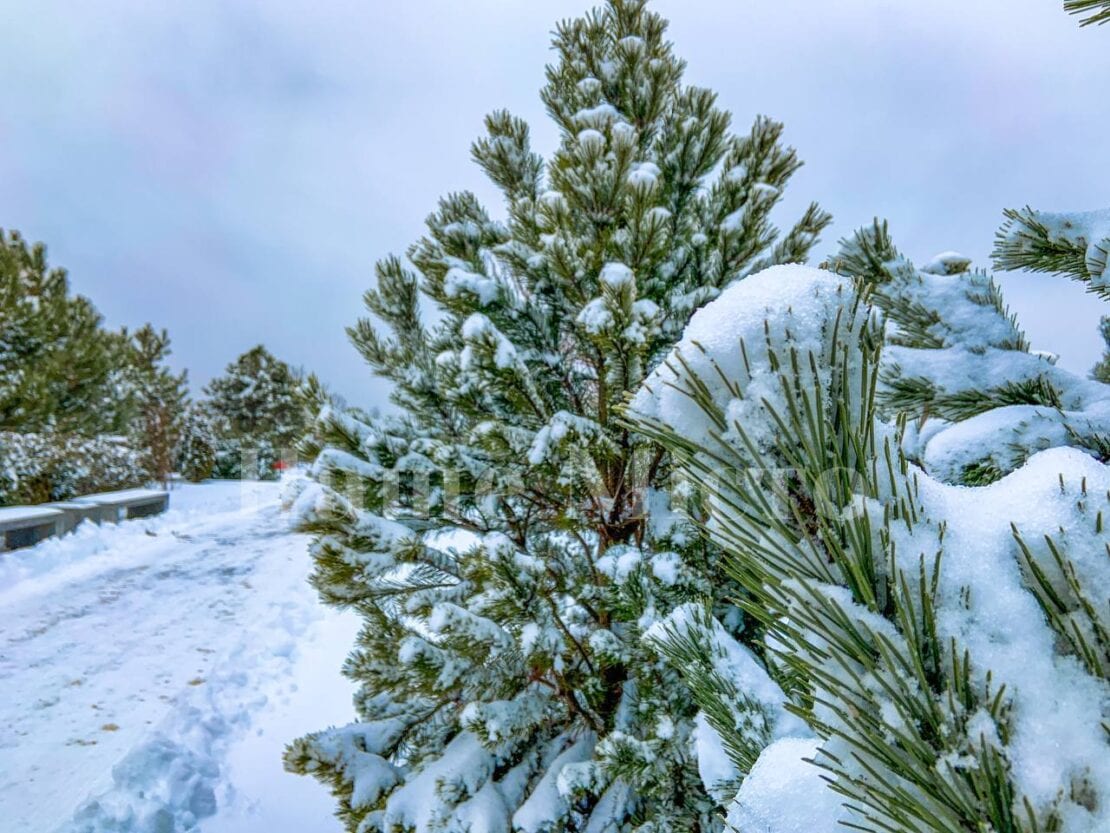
(0, 432, 149, 505)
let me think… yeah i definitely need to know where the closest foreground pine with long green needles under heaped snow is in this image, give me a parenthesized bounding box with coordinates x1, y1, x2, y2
(627, 257, 1110, 833)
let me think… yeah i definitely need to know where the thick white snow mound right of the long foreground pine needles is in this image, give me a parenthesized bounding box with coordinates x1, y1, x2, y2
(912, 448, 1110, 817)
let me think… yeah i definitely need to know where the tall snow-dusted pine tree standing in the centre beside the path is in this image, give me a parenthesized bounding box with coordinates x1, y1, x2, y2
(286, 0, 828, 833)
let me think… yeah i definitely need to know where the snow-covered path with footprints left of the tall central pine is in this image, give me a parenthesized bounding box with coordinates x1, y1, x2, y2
(0, 482, 355, 833)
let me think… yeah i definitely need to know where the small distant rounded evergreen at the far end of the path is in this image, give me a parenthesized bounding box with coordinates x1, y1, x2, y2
(204, 344, 310, 479)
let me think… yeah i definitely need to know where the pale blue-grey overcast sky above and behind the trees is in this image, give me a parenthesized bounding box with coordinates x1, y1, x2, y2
(0, 0, 1110, 404)
